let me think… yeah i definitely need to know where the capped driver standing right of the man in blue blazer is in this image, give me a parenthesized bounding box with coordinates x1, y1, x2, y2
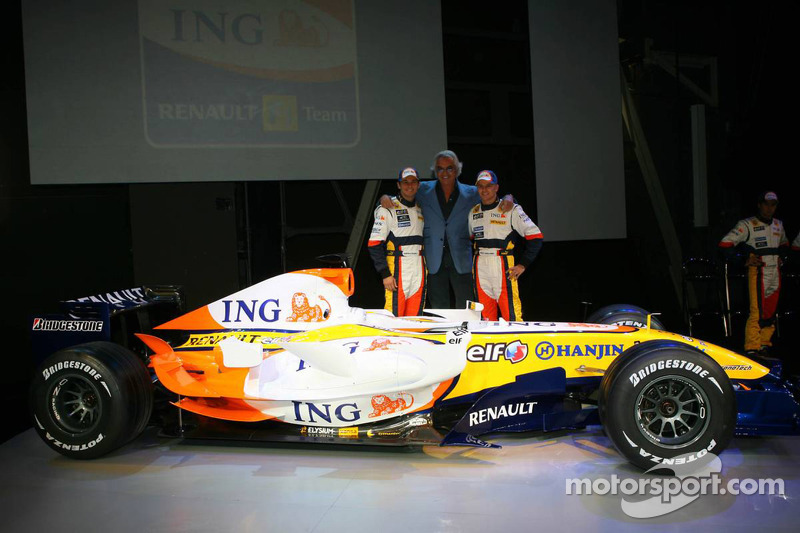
(468, 170, 543, 321)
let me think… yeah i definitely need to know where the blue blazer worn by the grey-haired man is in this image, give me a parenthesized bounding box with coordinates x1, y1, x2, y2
(417, 180, 481, 274)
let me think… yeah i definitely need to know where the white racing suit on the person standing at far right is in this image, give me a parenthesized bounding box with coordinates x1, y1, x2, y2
(719, 217, 789, 351)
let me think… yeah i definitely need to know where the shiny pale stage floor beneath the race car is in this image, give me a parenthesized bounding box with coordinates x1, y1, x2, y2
(0, 428, 800, 533)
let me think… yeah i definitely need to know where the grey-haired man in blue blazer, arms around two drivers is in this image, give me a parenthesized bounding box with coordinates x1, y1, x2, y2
(381, 150, 514, 309)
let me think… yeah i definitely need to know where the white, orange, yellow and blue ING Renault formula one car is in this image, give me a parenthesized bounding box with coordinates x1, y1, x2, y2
(26, 268, 800, 468)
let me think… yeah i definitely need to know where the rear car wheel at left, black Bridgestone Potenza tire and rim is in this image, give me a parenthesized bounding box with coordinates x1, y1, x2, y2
(30, 342, 153, 459)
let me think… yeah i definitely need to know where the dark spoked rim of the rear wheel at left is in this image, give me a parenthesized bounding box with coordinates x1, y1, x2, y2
(50, 375, 102, 433)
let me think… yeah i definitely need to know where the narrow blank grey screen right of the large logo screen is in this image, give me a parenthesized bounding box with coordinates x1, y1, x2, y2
(528, 0, 627, 241)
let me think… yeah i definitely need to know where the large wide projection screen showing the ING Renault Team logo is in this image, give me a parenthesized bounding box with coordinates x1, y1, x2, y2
(22, 0, 447, 184)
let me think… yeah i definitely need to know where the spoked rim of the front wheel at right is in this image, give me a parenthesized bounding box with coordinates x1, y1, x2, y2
(635, 376, 711, 449)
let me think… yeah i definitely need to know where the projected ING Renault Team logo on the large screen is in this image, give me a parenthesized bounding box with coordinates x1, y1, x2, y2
(139, 0, 360, 147)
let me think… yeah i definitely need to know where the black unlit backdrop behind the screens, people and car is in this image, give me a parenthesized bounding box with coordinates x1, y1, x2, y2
(0, 0, 800, 439)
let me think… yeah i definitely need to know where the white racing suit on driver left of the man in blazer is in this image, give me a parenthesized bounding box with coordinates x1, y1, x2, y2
(368, 197, 428, 316)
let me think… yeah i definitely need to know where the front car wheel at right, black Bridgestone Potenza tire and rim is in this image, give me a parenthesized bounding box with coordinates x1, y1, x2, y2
(598, 340, 737, 470)
